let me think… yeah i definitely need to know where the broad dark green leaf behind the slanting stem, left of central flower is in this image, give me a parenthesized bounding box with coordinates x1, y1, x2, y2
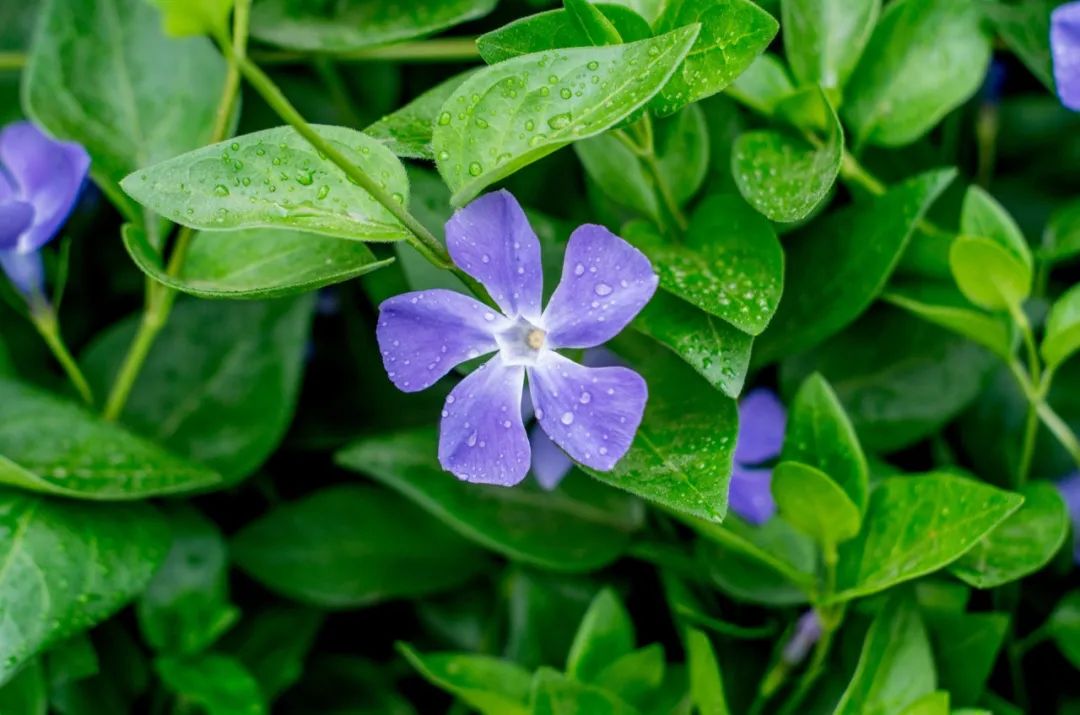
(83, 293, 314, 483)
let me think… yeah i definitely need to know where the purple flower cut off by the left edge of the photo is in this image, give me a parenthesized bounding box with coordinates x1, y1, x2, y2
(0, 122, 90, 296)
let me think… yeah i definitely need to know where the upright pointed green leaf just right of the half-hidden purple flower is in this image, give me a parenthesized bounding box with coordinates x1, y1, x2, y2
(783, 373, 869, 516)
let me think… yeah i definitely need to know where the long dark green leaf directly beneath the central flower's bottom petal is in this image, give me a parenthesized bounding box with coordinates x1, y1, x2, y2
(335, 429, 643, 571)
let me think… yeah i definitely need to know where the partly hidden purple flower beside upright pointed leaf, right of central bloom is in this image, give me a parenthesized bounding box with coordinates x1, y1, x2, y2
(728, 388, 787, 524)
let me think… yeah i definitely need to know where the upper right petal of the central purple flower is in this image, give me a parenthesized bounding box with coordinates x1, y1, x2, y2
(542, 224, 658, 348)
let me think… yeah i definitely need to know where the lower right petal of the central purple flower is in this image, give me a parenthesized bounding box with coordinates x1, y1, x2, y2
(528, 351, 648, 472)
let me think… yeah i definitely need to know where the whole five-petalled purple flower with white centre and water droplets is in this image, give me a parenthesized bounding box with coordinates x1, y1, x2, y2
(376, 191, 658, 486)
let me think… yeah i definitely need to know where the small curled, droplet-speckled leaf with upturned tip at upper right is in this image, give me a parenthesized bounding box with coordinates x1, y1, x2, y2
(731, 89, 843, 222)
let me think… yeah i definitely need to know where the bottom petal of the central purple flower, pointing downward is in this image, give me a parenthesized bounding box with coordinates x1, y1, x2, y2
(438, 355, 529, 487)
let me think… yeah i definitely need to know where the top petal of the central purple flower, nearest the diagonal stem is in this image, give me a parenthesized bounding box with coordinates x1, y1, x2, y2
(446, 191, 543, 323)
